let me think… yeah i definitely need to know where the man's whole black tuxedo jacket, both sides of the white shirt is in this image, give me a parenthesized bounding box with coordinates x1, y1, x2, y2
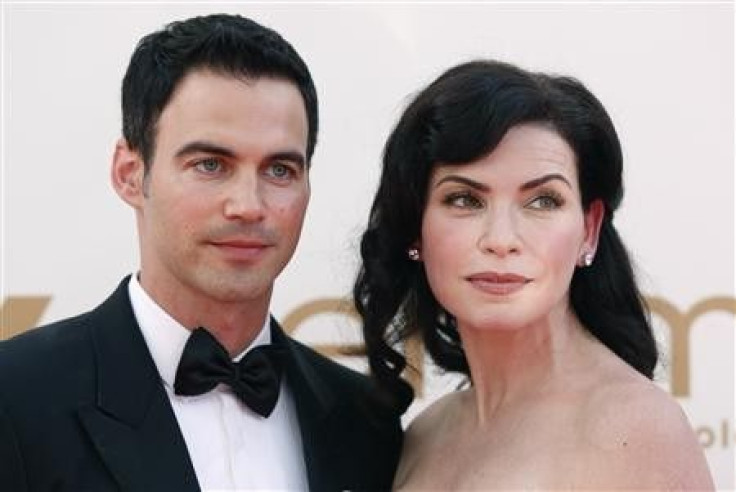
(0, 279, 404, 492)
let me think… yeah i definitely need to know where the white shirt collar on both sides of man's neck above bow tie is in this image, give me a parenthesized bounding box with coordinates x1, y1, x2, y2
(128, 275, 271, 388)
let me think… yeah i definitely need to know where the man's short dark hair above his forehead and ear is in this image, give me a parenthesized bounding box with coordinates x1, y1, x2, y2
(122, 14, 319, 168)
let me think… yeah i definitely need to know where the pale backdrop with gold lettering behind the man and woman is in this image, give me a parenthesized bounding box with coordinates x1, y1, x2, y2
(0, 2, 736, 489)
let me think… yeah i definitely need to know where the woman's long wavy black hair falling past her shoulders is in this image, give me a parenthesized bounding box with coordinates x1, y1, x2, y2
(353, 60, 657, 402)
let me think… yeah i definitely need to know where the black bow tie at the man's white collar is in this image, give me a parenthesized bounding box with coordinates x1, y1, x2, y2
(174, 328, 283, 417)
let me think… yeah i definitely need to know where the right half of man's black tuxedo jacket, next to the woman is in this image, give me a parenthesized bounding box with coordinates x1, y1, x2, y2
(280, 332, 405, 491)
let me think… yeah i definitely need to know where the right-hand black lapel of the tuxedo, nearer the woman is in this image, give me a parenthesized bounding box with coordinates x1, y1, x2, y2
(271, 318, 342, 491)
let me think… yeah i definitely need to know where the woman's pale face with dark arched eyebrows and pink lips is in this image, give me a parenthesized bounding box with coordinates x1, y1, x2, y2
(418, 124, 603, 329)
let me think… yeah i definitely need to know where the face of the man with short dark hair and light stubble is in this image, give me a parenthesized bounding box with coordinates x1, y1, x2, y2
(120, 70, 309, 304)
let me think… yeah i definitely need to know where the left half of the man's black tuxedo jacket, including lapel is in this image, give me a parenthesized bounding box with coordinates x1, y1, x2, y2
(0, 279, 197, 491)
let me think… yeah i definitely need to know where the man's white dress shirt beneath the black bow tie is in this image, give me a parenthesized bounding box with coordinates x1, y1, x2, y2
(128, 275, 309, 491)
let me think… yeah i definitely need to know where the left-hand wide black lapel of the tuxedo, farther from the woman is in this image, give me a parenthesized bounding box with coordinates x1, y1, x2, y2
(79, 279, 199, 491)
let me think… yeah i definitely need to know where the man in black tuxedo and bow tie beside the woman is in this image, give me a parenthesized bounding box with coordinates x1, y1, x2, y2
(0, 15, 405, 491)
